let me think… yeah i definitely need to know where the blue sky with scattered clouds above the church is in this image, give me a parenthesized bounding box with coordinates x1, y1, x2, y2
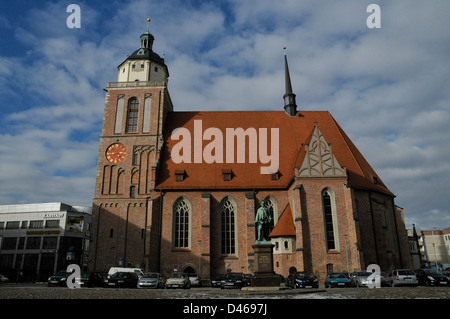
(0, 0, 450, 229)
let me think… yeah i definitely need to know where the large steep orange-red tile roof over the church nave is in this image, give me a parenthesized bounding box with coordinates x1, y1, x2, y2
(156, 111, 393, 195)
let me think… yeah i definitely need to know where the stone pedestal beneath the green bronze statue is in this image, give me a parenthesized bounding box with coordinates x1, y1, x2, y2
(252, 242, 280, 287)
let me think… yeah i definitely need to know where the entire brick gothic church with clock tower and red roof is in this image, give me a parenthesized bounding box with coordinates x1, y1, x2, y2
(89, 23, 411, 280)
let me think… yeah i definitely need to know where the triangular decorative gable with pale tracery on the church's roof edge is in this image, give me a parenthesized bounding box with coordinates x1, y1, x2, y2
(298, 123, 346, 177)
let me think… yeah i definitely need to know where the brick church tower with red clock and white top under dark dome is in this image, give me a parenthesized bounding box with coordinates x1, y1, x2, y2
(90, 19, 173, 271)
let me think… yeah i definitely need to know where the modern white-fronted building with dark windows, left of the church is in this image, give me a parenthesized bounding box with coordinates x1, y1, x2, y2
(0, 203, 92, 281)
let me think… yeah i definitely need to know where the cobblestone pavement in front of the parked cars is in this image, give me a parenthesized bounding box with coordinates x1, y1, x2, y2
(0, 284, 450, 299)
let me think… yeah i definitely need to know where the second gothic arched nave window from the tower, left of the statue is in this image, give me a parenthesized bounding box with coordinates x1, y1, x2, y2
(220, 197, 236, 255)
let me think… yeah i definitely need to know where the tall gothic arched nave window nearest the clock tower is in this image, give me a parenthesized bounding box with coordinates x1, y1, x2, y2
(173, 198, 191, 248)
